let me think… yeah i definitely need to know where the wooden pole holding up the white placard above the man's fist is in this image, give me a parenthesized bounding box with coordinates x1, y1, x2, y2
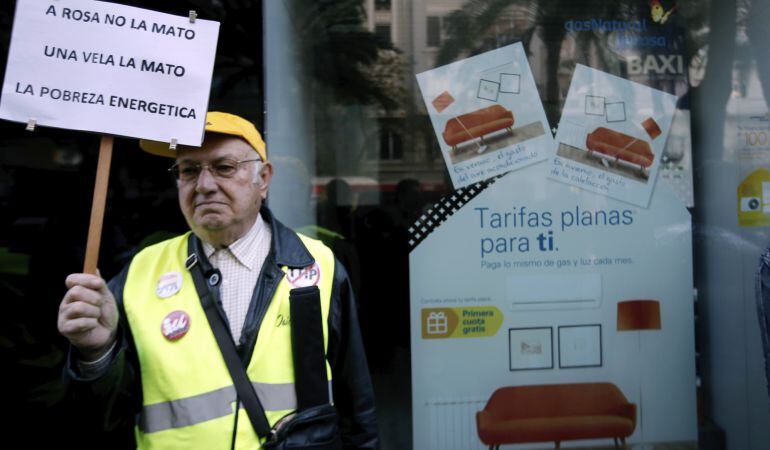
(83, 136, 113, 275)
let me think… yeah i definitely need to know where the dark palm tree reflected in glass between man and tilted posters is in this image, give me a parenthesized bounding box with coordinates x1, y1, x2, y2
(288, 0, 405, 174)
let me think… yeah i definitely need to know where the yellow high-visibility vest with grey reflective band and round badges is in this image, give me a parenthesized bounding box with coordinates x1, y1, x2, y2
(123, 233, 334, 450)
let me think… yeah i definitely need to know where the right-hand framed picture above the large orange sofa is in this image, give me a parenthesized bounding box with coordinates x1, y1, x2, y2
(559, 325, 602, 369)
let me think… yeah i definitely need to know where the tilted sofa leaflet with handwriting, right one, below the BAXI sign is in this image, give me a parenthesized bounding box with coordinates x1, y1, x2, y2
(548, 65, 676, 207)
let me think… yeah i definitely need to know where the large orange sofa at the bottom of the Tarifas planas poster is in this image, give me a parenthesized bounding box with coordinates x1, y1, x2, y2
(476, 383, 636, 450)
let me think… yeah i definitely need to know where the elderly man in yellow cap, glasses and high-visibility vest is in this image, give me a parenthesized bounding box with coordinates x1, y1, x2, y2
(58, 112, 378, 449)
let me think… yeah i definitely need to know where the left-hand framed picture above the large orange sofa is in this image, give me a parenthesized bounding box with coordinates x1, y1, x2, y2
(508, 327, 553, 371)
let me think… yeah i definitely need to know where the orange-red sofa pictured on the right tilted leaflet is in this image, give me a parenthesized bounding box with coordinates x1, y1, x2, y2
(586, 127, 655, 176)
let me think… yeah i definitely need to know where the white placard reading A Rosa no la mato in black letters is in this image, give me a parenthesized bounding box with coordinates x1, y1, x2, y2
(0, 0, 219, 146)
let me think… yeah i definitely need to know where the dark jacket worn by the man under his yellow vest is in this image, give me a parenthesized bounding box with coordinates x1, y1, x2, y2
(64, 207, 379, 449)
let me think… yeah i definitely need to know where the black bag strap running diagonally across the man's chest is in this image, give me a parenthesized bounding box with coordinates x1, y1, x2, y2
(185, 233, 272, 438)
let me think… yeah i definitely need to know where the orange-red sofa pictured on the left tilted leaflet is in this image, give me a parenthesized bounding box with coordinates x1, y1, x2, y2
(442, 105, 513, 151)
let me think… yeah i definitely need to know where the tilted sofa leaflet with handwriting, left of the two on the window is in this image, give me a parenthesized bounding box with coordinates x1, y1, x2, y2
(417, 43, 553, 189)
